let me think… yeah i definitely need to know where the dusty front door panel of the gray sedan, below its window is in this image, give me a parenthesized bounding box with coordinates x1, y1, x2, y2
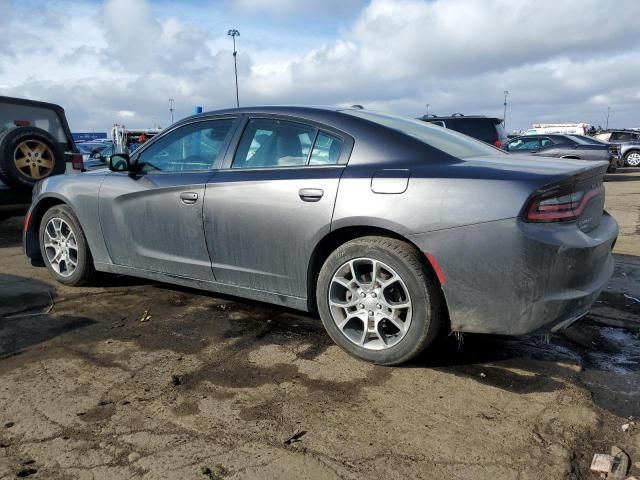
(100, 171, 214, 280)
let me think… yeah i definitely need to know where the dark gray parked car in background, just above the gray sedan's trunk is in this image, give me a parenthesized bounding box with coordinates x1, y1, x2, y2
(504, 135, 620, 173)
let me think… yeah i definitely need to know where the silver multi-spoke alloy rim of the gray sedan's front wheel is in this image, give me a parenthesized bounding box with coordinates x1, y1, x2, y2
(44, 217, 78, 277)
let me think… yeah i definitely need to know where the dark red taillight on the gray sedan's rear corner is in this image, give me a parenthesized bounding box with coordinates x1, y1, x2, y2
(524, 183, 604, 222)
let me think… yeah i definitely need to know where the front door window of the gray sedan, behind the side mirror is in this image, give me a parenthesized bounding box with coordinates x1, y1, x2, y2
(138, 118, 234, 173)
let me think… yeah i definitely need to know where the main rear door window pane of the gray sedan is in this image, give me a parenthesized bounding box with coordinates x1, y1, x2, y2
(231, 118, 317, 168)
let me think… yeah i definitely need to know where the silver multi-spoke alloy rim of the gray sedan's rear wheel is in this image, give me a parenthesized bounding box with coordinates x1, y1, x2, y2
(329, 258, 412, 350)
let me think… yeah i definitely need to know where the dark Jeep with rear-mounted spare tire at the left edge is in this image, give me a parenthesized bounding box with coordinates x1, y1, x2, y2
(0, 96, 80, 219)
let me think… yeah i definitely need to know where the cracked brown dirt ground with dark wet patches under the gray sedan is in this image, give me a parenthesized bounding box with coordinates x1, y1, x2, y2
(0, 169, 640, 480)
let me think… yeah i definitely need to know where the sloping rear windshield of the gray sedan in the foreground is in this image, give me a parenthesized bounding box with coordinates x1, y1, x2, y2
(342, 110, 507, 158)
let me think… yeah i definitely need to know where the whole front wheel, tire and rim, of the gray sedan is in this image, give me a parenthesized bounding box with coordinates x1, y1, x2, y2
(39, 205, 95, 285)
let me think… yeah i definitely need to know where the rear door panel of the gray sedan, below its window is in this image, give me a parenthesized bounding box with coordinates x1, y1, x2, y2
(204, 166, 342, 297)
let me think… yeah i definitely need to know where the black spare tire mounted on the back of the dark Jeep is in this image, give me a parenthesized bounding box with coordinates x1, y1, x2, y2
(0, 127, 66, 190)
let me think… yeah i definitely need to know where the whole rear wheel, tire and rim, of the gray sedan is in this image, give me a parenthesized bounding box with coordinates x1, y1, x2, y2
(316, 237, 442, 365)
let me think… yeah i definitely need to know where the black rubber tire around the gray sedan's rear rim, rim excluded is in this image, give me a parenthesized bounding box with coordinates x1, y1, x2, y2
(316, 236, 444, 365)
